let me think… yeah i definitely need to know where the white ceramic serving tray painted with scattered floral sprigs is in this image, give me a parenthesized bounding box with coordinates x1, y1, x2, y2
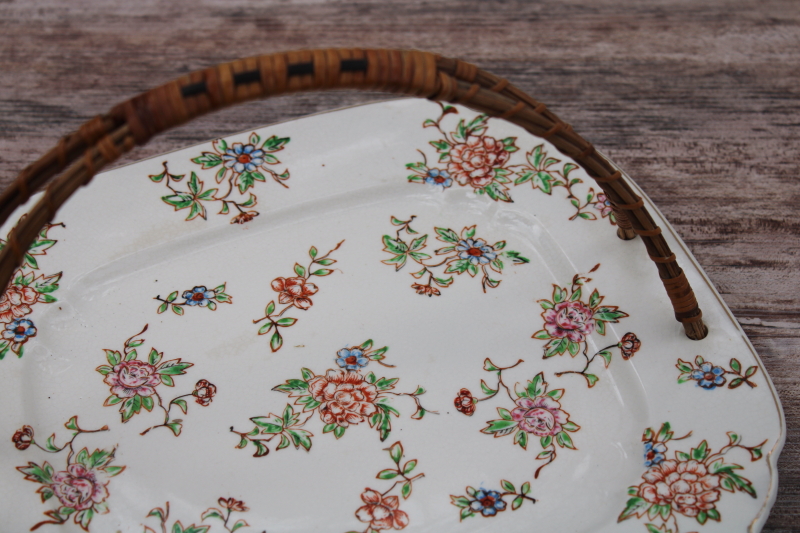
(0, 100, 785, 533)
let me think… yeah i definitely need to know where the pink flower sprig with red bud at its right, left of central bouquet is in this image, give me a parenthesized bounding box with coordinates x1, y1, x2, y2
(96, 325, 217, 437)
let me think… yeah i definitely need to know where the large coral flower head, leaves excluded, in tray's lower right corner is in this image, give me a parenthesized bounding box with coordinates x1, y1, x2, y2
(639, 459, 719, 518)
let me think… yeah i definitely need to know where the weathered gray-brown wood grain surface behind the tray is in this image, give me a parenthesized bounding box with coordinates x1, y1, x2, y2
(0, 0, 800, 533)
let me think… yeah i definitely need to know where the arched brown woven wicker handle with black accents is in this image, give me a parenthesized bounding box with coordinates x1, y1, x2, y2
(0, 49, 707, 339)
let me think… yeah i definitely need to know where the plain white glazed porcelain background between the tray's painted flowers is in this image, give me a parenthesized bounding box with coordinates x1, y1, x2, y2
(0, 100, 785, 533)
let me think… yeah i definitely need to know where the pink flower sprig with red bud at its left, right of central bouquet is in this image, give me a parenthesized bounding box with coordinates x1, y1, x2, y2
(454, 358, 580, 478)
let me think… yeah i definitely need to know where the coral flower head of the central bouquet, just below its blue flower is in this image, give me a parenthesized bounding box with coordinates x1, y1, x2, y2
(308, 370, 378, 427)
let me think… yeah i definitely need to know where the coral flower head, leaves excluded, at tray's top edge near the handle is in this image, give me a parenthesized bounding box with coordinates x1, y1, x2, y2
(447, 136, 510, 189)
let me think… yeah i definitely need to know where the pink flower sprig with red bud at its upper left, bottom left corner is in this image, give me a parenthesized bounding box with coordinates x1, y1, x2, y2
(11, 416, 125, 531)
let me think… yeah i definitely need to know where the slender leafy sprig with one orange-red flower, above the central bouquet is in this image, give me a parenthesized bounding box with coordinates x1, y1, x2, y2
(253, 240, 344, 352)
